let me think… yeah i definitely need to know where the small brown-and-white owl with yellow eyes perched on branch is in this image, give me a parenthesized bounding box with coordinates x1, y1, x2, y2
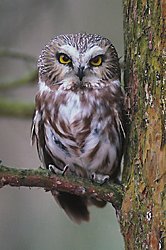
(32, 33, 125, 223)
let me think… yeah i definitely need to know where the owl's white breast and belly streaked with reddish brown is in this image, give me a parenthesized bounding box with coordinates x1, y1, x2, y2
(36, 89, 119, 177)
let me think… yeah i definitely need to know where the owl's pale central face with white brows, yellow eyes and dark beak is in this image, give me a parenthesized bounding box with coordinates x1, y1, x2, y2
(56, 45, 105, 87)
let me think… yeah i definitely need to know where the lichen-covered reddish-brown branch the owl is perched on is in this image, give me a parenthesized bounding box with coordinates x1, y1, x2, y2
(0, 165, 124, 210)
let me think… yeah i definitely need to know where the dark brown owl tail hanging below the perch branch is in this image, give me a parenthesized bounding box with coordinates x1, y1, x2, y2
(52, 191, 106, 224)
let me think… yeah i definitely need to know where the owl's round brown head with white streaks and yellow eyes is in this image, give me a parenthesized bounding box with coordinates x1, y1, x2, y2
(38, 33, 120, 90)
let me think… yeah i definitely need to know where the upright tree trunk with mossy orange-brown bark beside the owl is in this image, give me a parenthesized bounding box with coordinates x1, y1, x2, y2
(120, 0, 166, 250)
